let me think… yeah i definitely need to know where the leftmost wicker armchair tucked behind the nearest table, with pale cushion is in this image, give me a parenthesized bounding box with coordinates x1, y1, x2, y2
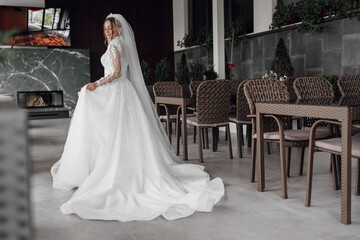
(244, 79, 329, 198)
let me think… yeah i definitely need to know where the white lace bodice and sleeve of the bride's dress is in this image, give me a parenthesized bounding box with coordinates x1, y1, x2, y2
(101, 36, 128, 81)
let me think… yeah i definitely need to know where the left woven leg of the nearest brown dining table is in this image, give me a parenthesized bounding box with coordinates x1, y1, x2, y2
(256, 113, 265, 192)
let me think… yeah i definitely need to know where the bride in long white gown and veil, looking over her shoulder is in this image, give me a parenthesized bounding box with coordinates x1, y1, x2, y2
(51, 14, 224, 222)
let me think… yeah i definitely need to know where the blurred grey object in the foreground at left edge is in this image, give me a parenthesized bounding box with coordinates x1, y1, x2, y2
(0, 102, 31, 240)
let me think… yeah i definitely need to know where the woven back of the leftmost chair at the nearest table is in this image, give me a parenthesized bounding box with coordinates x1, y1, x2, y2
(244, 79, 292, 132)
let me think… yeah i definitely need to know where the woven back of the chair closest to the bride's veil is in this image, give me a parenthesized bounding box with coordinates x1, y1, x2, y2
(153, 82, 183, 115)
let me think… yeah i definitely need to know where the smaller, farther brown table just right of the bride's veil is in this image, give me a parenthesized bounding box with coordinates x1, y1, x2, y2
(155, 96, 195, 160)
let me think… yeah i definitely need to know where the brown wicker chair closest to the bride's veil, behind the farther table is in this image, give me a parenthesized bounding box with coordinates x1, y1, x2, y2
(153, 82, 183, 142)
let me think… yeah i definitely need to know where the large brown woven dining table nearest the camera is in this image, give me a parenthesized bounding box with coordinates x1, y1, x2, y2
(255, 102, 360, 225)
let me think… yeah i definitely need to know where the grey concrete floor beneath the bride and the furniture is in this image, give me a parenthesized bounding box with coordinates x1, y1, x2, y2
(29, 119, 360, 240)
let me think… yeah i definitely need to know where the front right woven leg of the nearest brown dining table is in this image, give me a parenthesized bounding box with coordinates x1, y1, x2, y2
(341, 114, 351, 224)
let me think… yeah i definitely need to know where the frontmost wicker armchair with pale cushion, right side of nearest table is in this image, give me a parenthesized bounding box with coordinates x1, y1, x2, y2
(305, 120, 360, 207)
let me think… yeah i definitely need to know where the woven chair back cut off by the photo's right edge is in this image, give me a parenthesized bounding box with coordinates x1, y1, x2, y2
(337, 75, 360, 105)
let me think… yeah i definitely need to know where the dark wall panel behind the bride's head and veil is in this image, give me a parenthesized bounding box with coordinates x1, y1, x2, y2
(46, 0, 174, 81)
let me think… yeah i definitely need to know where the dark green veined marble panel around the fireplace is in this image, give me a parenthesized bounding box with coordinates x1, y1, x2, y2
(0, 48, 90, 108)
